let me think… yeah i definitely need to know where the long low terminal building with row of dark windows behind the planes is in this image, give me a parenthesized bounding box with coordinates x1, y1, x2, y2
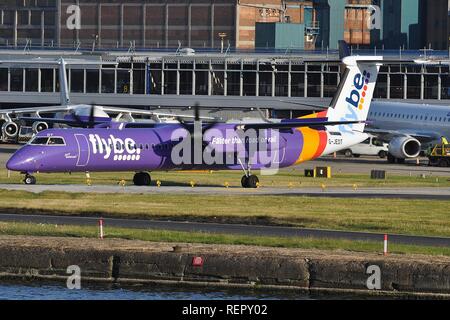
(0, 51, 450, 109)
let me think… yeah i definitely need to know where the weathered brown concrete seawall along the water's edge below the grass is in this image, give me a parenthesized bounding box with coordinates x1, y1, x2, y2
(0, 236, 450, 299)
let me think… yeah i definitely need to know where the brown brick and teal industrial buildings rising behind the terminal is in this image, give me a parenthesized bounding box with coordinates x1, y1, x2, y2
(0, 0, 449, 50)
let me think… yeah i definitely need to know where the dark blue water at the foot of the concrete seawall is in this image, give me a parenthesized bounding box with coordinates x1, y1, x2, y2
(0, 282, 313, 300)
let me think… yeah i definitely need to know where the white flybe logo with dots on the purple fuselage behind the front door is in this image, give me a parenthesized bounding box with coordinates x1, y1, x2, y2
(89, 134, 141, 161)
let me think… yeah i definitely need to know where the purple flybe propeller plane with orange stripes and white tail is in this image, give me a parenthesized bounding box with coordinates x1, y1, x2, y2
(6, 56, 383, 188)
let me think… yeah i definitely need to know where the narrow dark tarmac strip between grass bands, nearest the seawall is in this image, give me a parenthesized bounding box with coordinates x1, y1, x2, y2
(0, 214, 450, 247)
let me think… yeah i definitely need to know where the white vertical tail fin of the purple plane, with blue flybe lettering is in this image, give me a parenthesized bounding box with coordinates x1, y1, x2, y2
(327, 57, 383, 132)
